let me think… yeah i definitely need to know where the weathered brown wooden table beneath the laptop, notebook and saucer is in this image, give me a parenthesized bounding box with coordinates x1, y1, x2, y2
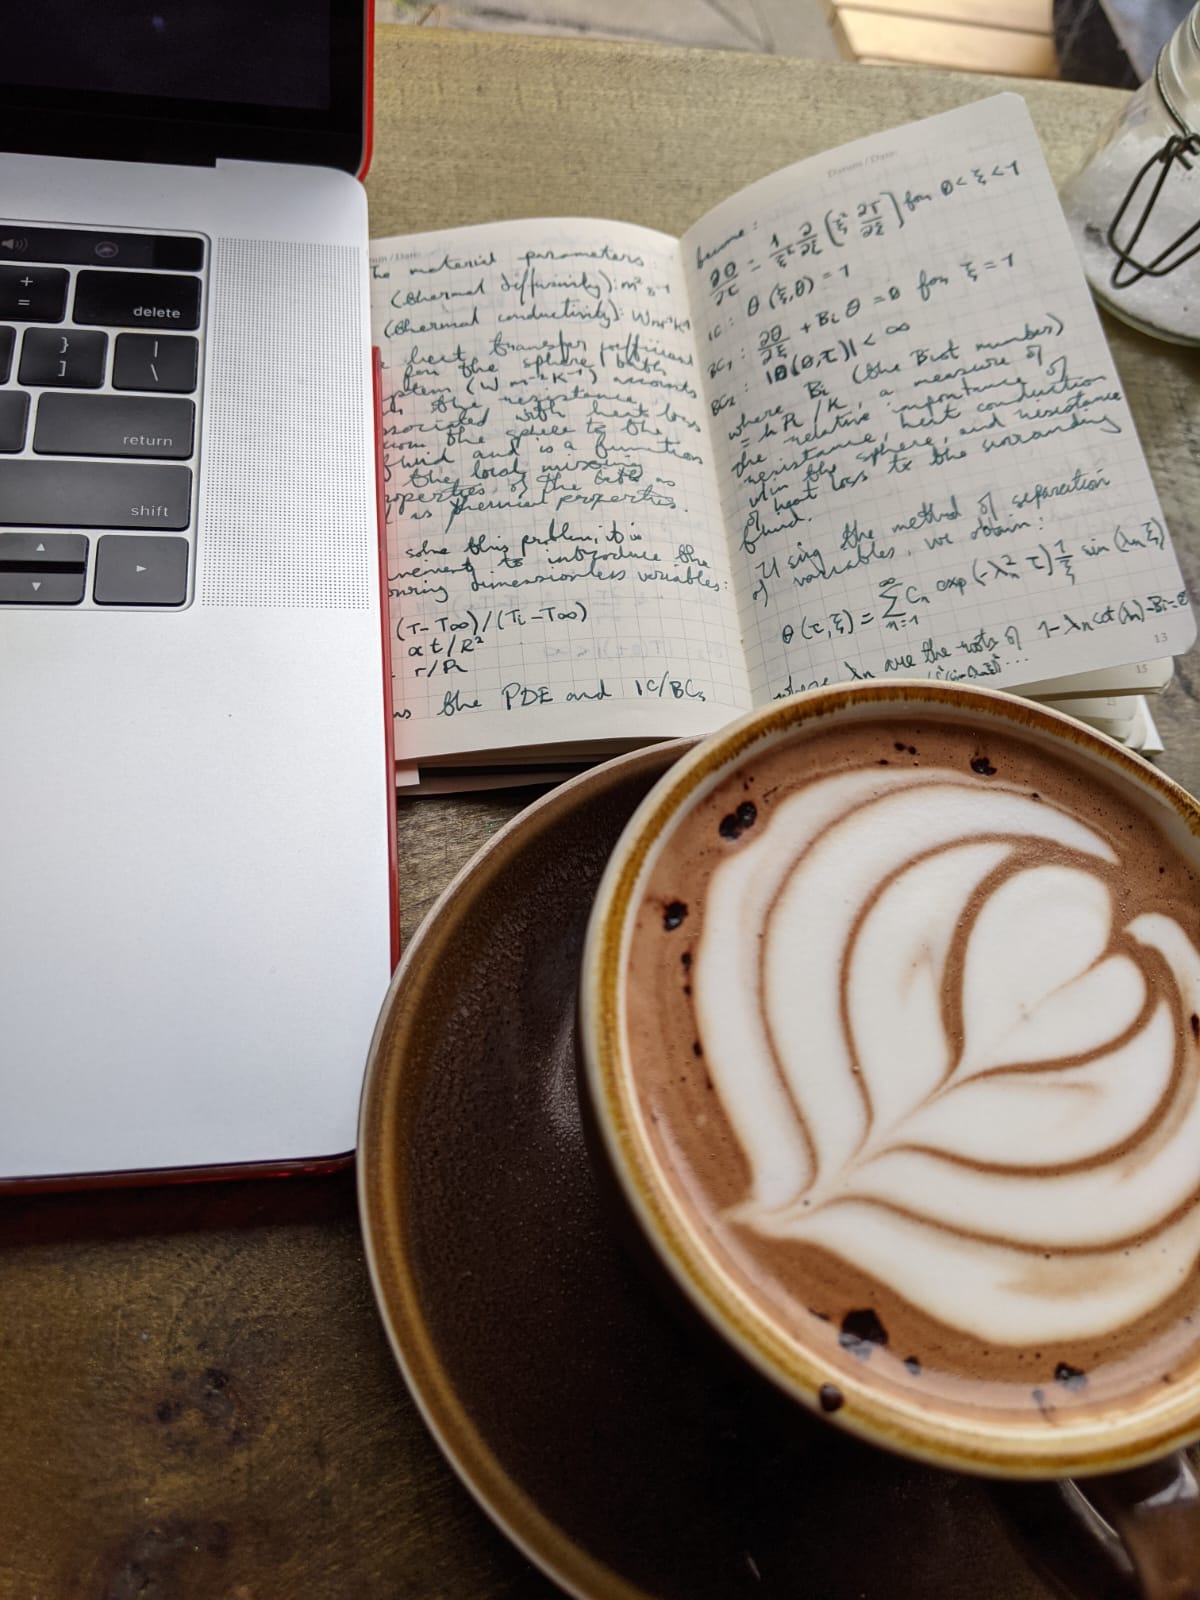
(0, 29, 1200, 1600)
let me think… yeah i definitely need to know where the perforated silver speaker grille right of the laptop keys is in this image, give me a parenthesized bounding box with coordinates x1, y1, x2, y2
(197, 238, 376, 610)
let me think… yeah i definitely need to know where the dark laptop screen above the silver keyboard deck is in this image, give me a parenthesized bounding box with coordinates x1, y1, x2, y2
(0, 0, 366, 171)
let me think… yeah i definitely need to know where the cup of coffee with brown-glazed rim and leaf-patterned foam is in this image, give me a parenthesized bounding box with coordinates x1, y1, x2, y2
(579, 682, 1200, 1597)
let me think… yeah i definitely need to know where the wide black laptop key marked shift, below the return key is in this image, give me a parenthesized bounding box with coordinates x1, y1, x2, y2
(0, 461, 192, 531)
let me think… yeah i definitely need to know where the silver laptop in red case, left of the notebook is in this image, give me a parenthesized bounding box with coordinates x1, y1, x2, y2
(0, 0, 395, 1187)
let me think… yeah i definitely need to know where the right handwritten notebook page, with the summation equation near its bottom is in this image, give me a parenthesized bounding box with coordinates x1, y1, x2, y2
(682, 94, 1195, 702)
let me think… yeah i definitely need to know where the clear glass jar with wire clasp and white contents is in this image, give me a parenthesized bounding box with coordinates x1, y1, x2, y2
(1062, 3, 1200, 344)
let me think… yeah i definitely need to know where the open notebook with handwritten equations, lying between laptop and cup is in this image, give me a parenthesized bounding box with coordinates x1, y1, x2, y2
(371, 94, 1195, 774)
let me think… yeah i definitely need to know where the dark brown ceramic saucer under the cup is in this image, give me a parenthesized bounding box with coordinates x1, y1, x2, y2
(358, 744, 1125, 1600)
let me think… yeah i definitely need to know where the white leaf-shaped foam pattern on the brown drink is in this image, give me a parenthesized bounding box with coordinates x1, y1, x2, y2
(693, 765, 1200, 1346)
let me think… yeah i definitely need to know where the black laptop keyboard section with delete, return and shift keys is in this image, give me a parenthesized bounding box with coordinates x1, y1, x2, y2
(0, 232, 205, 610)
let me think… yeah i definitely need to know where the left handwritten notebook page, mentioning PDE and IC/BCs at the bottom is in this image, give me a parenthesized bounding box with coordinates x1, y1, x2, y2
(371, 221, 749, 762)
